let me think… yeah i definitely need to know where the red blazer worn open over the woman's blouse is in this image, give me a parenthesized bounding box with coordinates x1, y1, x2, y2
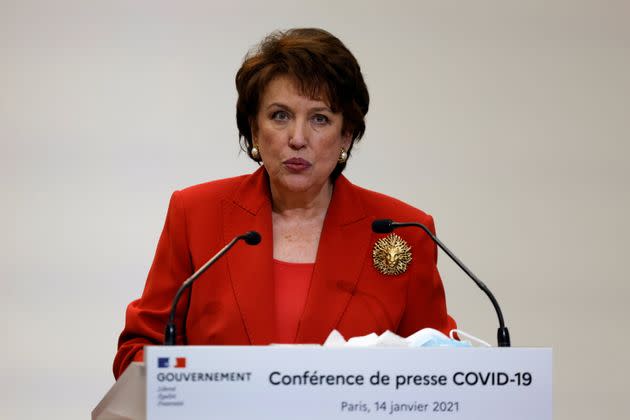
(114, 168, 455, 377)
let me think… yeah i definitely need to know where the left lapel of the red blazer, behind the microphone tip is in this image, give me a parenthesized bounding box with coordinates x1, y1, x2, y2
(222, 168, 275, 345)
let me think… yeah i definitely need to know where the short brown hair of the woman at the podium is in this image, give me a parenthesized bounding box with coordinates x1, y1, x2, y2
(236, 28, 370, 178)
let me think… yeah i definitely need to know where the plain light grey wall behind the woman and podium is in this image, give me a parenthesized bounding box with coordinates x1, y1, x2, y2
(0, 0, 630, 419)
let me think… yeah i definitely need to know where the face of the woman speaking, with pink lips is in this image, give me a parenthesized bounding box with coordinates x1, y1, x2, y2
(254, 76, 351, 203)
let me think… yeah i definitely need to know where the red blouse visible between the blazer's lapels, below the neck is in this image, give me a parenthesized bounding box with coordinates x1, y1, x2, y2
(273, 259, 315, 344)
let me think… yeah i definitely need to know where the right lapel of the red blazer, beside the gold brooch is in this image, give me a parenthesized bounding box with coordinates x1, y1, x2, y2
(296, 176, 372, 343)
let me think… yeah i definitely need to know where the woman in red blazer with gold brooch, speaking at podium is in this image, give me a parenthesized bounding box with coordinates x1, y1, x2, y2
(114, 29, 455, 377)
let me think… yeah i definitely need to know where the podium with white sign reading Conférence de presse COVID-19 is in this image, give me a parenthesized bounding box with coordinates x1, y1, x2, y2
(92, 346, 552, 420)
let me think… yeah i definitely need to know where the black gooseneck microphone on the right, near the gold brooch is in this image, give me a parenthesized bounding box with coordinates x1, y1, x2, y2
(372, 219, 510, 347)
